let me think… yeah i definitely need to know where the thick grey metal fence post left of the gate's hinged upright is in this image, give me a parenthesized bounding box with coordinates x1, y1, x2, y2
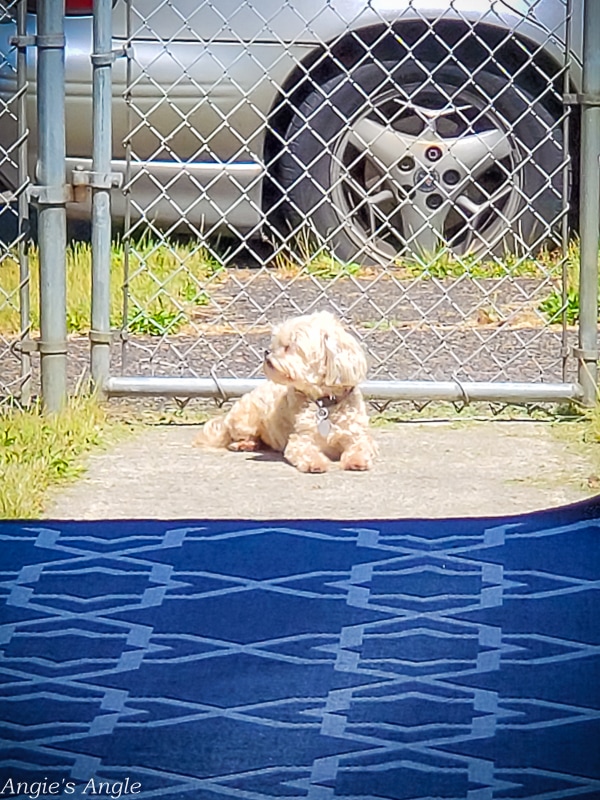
(32, 0, 67, 412)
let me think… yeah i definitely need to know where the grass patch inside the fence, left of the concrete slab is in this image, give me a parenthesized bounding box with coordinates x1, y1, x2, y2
(0, 397, 131, 519)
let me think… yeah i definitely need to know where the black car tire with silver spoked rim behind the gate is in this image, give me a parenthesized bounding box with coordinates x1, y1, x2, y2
(278, 62, 564, 264)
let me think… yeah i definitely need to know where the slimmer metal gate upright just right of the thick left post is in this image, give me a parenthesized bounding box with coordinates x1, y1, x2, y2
(90, 0, 115, 394)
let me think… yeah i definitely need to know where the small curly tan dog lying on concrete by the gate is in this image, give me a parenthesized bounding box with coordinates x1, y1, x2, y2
(198, 311, 375, 472)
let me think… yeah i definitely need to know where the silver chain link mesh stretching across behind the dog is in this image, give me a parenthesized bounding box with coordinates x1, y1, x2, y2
(0, 0, 590, 410)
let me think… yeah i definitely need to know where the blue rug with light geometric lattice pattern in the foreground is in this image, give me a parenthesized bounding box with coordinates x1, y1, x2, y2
(0, 501, 600, 800)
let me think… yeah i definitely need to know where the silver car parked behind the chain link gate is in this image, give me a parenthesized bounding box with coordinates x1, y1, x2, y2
(0, 0, 581, 263)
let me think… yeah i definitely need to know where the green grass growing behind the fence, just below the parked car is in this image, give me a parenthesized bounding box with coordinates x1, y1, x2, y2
(0, 234, 596, 336)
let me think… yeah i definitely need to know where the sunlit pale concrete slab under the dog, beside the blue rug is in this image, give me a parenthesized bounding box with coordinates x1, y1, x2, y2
(46, 421, 595, 519)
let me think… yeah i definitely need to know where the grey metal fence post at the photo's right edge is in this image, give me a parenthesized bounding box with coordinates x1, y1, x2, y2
(577, 0, 600, 406)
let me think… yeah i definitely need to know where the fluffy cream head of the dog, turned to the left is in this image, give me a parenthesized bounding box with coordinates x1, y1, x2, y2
(264, 311, 367, 393)
